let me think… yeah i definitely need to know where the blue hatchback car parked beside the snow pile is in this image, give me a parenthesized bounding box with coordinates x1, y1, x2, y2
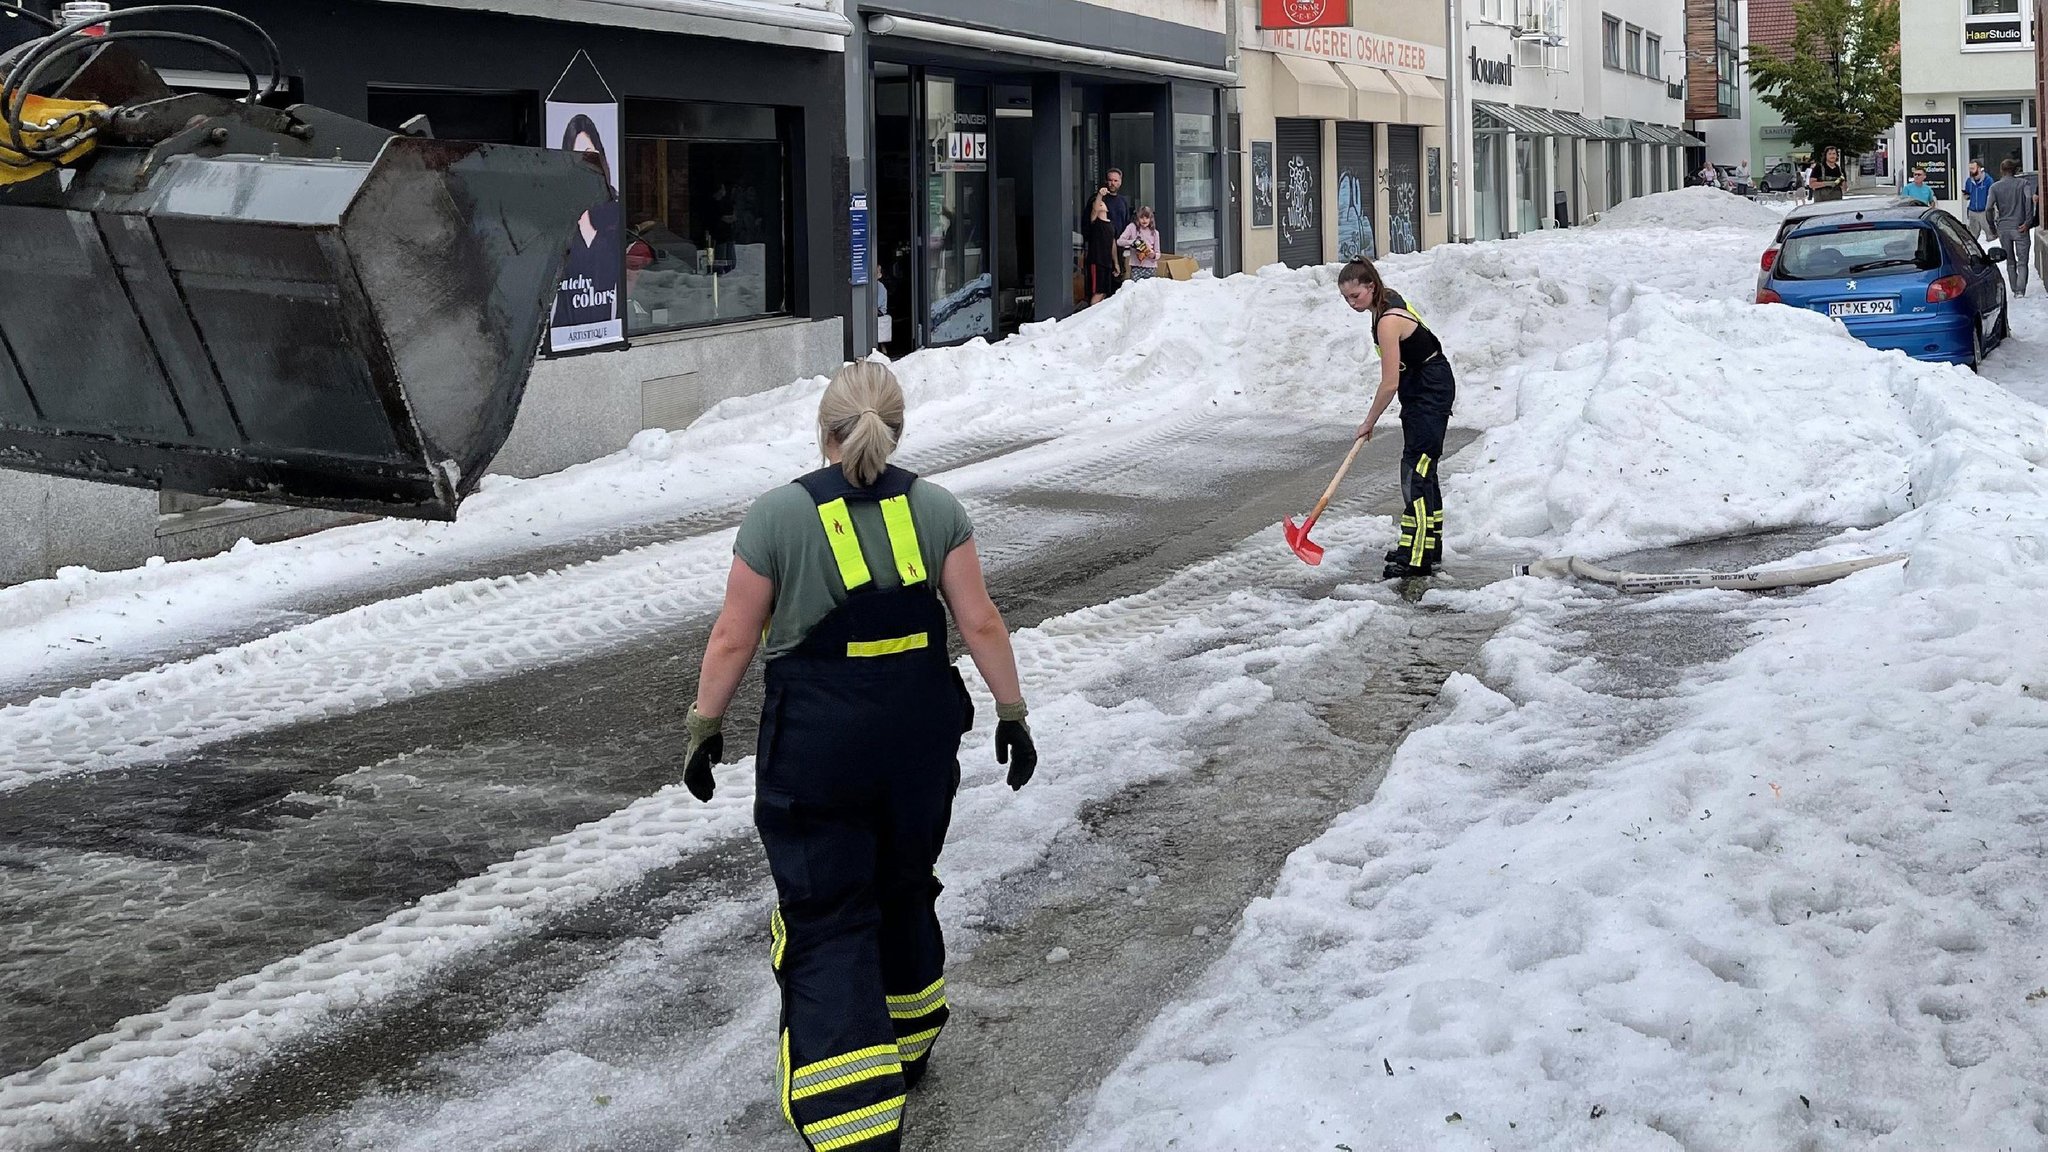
(1757, 203, 2009, 367)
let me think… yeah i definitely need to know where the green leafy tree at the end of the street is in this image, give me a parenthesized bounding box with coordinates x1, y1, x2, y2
(1749, 0, 1905, 156)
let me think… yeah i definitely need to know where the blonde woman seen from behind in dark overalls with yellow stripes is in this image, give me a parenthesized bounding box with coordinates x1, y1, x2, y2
(682, 361, 1038, 1152)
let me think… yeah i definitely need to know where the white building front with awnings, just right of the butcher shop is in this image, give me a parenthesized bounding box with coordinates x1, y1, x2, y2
(1454, 0, 1706, 240)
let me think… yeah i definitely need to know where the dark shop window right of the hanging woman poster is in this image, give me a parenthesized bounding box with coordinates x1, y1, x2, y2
(618, 100, 793, 334)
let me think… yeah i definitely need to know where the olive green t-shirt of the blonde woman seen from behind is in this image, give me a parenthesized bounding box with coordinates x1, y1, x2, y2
(733, 480, 975, 660)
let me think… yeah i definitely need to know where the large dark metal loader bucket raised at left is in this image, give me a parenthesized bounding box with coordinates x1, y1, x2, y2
(0, 48, 606, 519)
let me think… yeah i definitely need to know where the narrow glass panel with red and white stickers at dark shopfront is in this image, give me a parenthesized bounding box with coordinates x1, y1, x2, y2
(924, 76, 995, 346)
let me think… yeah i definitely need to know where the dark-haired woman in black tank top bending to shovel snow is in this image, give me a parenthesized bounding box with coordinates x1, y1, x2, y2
(1337, 258, 1458, 578)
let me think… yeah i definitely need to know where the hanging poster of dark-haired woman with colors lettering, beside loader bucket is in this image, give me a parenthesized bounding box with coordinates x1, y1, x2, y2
(547, 51, 627, 357)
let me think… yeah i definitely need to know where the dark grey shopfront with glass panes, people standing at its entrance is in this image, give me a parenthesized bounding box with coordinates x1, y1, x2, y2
(846, 0, 1237, 355)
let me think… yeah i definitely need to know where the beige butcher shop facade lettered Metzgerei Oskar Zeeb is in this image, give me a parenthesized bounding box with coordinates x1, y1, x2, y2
(1231, 0, 1452, 269)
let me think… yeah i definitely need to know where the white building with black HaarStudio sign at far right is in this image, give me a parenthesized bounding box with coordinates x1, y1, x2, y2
(1898, 0, 2042, 209)
